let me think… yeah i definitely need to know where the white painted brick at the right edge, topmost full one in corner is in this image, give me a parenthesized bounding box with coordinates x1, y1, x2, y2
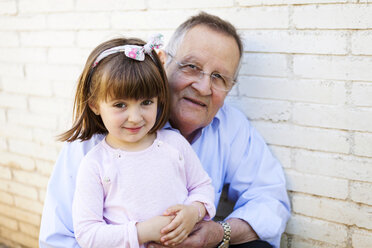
(293, 4, 372, 29)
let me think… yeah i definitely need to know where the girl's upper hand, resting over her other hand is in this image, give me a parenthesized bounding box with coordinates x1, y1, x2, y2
(160, 202, 206, 246)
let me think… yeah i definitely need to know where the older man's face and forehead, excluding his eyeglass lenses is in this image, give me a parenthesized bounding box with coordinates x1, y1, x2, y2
(166, 25, 239, 141)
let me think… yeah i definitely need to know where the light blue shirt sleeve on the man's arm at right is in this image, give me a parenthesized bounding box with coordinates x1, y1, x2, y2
(226, 113, 290, 247)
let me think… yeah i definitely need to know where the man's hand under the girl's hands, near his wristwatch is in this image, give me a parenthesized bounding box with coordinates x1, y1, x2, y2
(147, 221, 223, 248)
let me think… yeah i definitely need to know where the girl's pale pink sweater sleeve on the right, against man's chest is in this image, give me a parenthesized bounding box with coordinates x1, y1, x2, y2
(179, 135, 216, 220)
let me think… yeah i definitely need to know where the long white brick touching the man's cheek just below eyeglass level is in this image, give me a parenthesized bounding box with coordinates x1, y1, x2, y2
(238, 76, 346, 104)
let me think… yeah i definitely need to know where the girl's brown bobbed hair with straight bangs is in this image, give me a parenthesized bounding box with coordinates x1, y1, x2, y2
(58, 38, 169, 142)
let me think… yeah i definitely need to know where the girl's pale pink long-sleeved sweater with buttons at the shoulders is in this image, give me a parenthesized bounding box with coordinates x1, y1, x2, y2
(72, 130, 216, 248)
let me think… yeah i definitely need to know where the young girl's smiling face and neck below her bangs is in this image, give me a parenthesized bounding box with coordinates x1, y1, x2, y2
(90, 97, 158, 151)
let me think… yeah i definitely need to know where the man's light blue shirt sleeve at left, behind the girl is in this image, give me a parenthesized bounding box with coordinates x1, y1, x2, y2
(39, 138, 98, 248)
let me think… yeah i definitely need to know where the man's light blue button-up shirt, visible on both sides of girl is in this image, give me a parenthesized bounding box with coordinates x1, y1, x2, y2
(39, 104, 290, 248)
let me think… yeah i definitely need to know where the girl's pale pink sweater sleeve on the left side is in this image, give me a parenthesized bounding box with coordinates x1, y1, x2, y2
(72, 154, 139, 248)
